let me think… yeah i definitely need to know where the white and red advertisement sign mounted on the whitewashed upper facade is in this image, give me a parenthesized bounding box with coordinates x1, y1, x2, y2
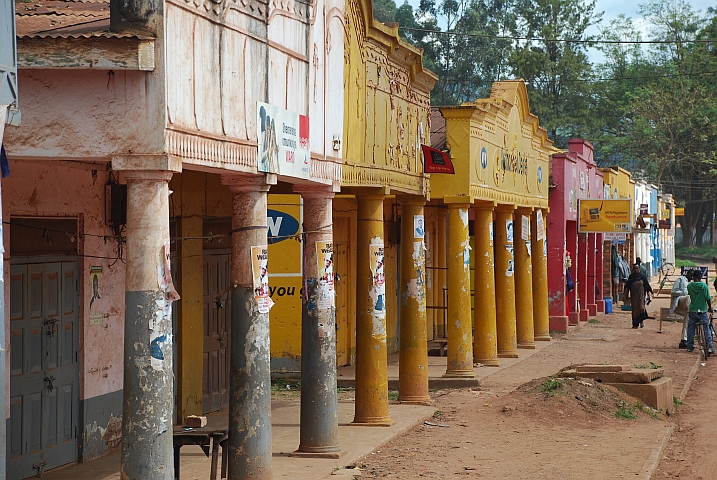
(256, 102, 311, 178)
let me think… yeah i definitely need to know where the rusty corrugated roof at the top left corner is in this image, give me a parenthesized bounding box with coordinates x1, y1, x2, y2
(15, 0, 151, 39)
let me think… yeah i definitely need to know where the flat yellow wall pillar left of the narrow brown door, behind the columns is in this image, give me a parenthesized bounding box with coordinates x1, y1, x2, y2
(171, 170, 204, 423)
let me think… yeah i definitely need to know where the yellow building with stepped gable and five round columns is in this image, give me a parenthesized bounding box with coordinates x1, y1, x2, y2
(426, 80, 555, 370)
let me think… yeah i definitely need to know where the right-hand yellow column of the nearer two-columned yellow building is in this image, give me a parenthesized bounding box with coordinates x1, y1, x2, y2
(398, 198, 431, 404)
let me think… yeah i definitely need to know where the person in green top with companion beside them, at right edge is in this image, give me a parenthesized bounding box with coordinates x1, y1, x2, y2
(670, 266, 717, 353)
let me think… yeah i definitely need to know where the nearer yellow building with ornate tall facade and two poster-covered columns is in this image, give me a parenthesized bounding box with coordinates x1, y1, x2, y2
(333, 0, 437, 425)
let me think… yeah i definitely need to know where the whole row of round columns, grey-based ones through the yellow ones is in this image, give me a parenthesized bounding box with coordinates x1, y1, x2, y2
(122, 171, 550, 480)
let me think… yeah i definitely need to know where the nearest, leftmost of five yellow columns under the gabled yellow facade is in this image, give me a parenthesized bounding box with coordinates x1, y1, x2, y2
(443, 196, 475, 377)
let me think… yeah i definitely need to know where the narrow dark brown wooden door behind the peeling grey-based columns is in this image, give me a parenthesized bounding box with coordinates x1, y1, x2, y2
(202, 254, 231, 413)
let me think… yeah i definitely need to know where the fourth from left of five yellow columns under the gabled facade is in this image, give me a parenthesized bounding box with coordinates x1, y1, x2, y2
(514, 208, 535, 348)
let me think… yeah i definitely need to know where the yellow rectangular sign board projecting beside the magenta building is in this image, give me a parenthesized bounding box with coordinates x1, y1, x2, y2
(578, 198, 633, 233)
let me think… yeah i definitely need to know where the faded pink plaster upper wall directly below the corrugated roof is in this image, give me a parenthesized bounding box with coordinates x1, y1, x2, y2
(5, 70, 165, 159)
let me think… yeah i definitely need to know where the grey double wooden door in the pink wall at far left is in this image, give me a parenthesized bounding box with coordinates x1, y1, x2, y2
(8, 262, 79, 480)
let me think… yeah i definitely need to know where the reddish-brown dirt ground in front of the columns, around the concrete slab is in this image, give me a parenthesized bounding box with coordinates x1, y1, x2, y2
(360, 313, 704, 479)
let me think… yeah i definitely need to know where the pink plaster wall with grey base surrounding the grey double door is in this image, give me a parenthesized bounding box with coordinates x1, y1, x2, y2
(3, 161, 125, 459)
